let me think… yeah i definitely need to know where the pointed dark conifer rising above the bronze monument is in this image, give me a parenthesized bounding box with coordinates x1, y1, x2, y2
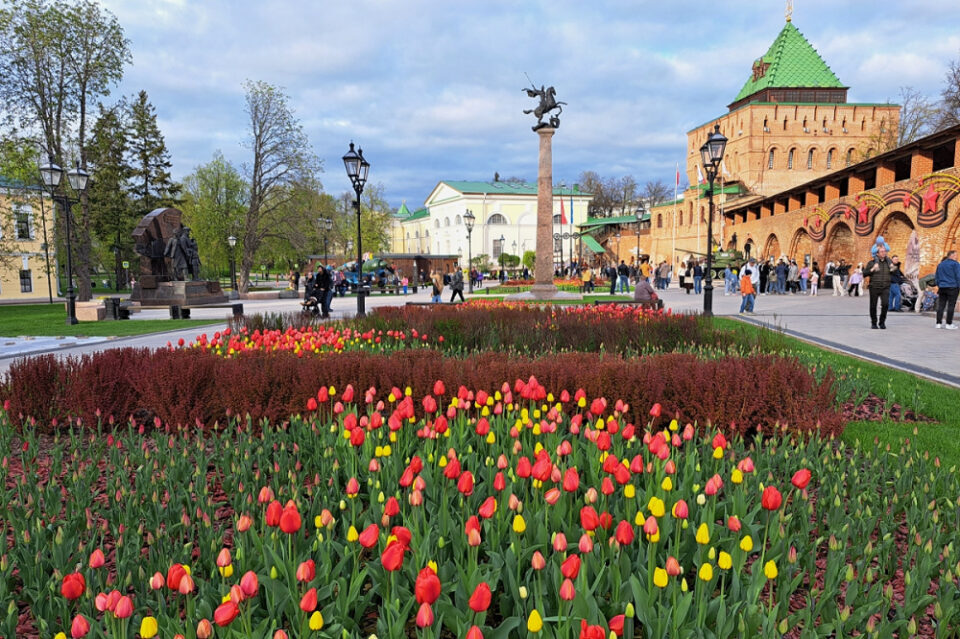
(127, 91, 182, 216)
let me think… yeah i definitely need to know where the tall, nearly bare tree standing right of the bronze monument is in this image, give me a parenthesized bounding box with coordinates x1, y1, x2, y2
(239, 81, 320, 292)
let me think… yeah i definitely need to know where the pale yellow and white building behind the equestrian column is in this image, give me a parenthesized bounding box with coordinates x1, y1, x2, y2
(391, 181, 593, 266)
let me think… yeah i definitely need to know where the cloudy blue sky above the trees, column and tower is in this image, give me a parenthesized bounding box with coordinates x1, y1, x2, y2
(102, 0, 960, 210)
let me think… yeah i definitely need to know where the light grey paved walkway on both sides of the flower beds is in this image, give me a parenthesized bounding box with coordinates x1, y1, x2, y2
(0, 286, 960, 387)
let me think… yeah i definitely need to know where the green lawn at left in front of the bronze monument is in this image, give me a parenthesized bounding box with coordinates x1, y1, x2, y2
(0, 303, 224, 337)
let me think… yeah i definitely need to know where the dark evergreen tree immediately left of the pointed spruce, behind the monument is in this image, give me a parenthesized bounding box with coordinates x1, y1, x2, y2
(84, 104, 131, 289)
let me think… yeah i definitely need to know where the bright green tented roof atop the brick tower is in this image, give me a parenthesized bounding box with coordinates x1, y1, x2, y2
(733, 22, 845, 102)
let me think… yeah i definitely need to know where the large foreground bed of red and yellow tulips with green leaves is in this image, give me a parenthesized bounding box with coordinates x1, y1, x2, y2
(0, 380, 960, 639)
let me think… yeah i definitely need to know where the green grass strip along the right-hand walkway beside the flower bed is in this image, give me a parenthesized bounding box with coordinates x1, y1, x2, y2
(714, 317, 960, 468)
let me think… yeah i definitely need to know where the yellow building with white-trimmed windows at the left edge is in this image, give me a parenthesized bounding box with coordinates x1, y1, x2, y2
(0, 178, 57, 301)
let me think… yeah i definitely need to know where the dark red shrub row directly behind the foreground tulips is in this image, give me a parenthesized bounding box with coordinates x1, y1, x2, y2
(4, 349, 843, 435)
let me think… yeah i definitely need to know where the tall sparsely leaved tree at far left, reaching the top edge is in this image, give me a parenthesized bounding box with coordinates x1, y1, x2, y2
(0, 0, 130, 300)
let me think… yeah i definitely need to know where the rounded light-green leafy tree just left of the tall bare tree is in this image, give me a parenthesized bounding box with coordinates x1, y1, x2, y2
(183, 151, 249, 278)
